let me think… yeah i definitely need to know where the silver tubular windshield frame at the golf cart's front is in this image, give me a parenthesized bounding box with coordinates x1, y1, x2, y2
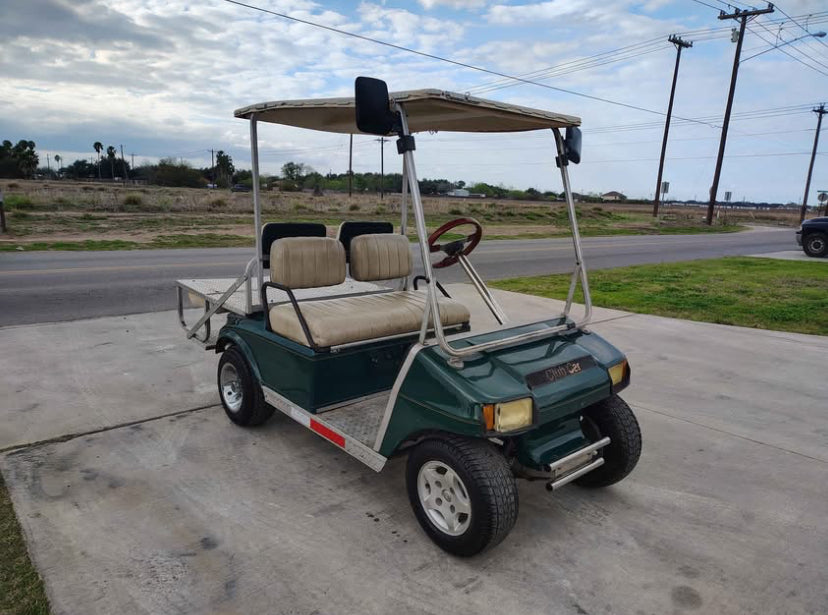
(394, 103, 592, 365)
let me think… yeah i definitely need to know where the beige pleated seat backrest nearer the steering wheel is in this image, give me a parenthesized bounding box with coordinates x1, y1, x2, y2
(351, 234, 411, 282)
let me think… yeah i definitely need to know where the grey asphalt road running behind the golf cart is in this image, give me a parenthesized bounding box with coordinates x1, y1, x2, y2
(0, 229, 796, 326)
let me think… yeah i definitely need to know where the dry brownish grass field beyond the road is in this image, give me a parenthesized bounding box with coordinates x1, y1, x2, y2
(0, 180, 796, 251)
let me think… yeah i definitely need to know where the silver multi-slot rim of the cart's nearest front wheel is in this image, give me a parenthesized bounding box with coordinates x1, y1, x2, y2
(417, 461, 471, 536)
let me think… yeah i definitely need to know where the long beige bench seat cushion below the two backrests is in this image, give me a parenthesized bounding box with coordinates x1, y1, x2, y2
(270, 290, 469, 347)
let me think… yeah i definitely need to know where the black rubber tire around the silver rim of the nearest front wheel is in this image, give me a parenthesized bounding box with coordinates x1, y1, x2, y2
(405, 437, 518, 557)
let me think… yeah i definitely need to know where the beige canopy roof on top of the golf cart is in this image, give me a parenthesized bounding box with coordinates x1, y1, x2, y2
(235, 90, 581, 134)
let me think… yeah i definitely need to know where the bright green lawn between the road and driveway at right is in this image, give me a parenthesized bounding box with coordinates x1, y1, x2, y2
(491, 257, 828, 335)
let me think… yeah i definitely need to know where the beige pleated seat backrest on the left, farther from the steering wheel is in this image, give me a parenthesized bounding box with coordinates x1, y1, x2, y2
(270, 237, 345, 289)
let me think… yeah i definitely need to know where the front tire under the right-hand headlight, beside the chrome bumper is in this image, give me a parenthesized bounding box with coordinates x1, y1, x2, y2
(574, 395, 641, 487)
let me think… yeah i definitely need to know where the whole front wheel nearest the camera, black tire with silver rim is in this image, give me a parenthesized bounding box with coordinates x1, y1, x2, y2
(405, 437, 518, 557)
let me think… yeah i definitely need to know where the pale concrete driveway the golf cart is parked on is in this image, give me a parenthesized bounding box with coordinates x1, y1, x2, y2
(0, 286, 828, 615)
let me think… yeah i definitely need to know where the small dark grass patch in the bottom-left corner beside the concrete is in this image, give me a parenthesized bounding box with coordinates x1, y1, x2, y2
(0, 475, 49, 615)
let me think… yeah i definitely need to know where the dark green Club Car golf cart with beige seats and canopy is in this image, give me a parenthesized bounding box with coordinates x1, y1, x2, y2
(178, 77, 641, 556)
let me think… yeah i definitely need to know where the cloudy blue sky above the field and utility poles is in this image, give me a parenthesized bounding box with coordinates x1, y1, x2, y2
(0, 0, 828, 204)
